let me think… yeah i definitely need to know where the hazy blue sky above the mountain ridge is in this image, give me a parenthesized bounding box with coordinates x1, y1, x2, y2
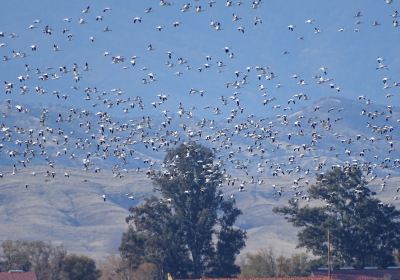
(0, 0, 400, 117)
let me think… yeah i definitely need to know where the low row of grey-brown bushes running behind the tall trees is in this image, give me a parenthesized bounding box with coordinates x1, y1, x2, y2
(0, 238, 315, 280)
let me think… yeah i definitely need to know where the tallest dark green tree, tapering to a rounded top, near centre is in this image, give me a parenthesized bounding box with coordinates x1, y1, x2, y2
(120, 142, 246, 277)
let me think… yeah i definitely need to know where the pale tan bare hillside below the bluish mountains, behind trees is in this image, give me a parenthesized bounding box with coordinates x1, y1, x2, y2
(0, 166, 400, 260)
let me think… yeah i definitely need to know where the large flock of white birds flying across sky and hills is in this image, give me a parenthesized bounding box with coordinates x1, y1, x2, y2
(0, 0, 400, 205)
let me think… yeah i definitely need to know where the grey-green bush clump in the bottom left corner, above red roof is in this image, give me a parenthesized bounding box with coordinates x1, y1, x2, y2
(0, 240, 100, 280)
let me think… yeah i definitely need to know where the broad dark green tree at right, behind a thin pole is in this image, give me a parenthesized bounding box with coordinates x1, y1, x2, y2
(274, 166, 400, 268)
